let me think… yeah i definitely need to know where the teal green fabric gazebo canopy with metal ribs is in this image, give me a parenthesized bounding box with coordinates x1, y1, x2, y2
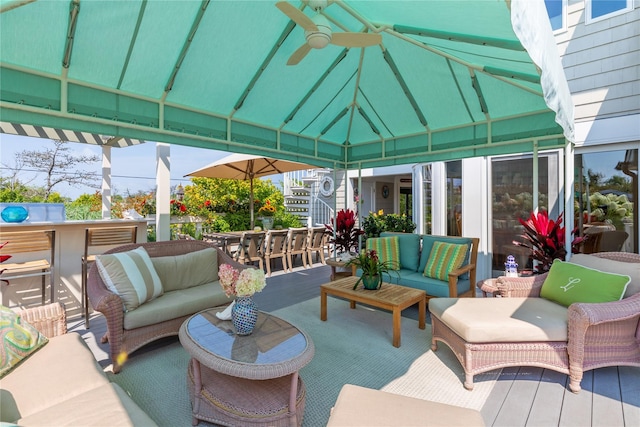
(0, 0, 573, 168)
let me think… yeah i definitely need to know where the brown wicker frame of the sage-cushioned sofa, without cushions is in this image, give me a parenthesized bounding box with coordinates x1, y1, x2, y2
(87, 240, 253, 373)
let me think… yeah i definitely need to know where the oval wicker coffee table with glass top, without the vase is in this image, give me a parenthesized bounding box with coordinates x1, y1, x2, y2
(179, 307, 314, 426)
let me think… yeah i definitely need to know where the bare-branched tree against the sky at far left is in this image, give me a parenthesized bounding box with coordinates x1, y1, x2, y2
(15, 140, 100, 201)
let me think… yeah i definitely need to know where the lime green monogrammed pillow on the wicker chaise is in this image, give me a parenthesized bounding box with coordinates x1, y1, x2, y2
(540, 259, 631, 307)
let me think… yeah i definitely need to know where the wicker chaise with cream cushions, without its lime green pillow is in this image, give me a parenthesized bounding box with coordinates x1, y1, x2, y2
(429, 252, 640, 393)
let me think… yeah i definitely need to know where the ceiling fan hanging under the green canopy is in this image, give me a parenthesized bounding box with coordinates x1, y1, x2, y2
(276, 0, 382, 65)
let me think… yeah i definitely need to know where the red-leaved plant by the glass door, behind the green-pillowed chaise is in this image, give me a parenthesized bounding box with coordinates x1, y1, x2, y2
(513, 210, 583, 273)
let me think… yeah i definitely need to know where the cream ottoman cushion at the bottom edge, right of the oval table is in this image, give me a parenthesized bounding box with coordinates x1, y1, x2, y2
(327, 384, 484, 427)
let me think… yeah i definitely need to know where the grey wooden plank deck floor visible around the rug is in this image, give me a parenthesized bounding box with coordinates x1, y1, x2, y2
(69, 264, 640, 427)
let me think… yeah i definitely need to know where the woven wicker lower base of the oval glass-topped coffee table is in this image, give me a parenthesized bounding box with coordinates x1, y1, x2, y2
(188, 363, 306, 427)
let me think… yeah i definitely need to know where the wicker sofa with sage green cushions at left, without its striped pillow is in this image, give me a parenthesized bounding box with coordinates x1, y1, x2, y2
(87, 240, 251, 373)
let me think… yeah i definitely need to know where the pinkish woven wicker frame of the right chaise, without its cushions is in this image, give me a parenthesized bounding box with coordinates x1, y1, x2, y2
(432, 252, 640, 392)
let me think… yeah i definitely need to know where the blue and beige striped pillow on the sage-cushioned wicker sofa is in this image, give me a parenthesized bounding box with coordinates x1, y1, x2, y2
(96, 247, 163, 311)
